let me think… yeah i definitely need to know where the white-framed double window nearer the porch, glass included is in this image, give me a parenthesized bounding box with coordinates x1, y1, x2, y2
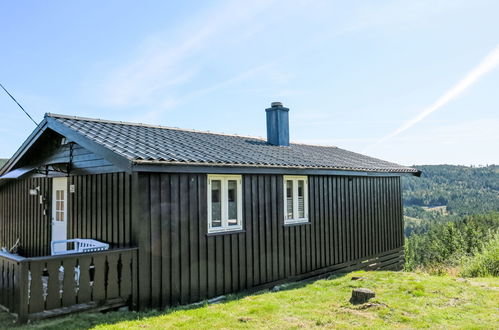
(208, 174, 243, 233)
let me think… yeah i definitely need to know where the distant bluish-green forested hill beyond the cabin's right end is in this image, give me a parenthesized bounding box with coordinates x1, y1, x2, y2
(402, 165, 499, 218)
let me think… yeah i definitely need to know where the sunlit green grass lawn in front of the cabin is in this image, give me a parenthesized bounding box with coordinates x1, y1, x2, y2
(0, 272, 499, 329)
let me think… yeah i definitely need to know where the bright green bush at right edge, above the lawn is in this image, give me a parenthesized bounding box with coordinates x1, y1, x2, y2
(461, 232, 499, 277)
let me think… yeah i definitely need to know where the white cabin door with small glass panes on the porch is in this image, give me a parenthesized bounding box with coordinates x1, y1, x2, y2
(52, 178, 68, 252)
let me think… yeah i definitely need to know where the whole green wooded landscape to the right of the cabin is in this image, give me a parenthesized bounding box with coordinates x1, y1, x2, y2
(402, 165, 499, 276)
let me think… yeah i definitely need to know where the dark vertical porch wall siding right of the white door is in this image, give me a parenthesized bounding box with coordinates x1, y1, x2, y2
(68, 173, 132, 248)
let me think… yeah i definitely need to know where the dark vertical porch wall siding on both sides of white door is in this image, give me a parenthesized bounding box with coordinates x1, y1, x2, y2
(0, 173, 132, 257)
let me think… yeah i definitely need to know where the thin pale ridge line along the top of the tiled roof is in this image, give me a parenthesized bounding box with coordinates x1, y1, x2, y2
(45, 112, 338, 148)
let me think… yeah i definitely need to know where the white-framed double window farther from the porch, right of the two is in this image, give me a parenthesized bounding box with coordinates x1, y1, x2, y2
(283, 175, 308, 224)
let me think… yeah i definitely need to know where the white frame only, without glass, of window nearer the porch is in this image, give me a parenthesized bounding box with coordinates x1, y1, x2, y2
(208, 174, 243, 233)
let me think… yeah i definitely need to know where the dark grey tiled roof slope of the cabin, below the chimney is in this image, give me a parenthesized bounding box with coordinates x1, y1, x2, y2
(46, 114, 417, 173)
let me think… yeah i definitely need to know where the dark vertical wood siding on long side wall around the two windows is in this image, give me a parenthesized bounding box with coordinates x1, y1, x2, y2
(137, 173, 403, 307)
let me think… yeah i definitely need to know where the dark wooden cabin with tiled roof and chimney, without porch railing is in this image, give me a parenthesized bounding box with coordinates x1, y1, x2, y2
(0, 103, 419, 320)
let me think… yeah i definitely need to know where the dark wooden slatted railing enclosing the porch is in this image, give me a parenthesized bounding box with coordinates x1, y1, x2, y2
(0, 248, 137, 323)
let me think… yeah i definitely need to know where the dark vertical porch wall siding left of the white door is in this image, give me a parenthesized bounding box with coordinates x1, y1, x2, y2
(0, 178, 52, 256)
